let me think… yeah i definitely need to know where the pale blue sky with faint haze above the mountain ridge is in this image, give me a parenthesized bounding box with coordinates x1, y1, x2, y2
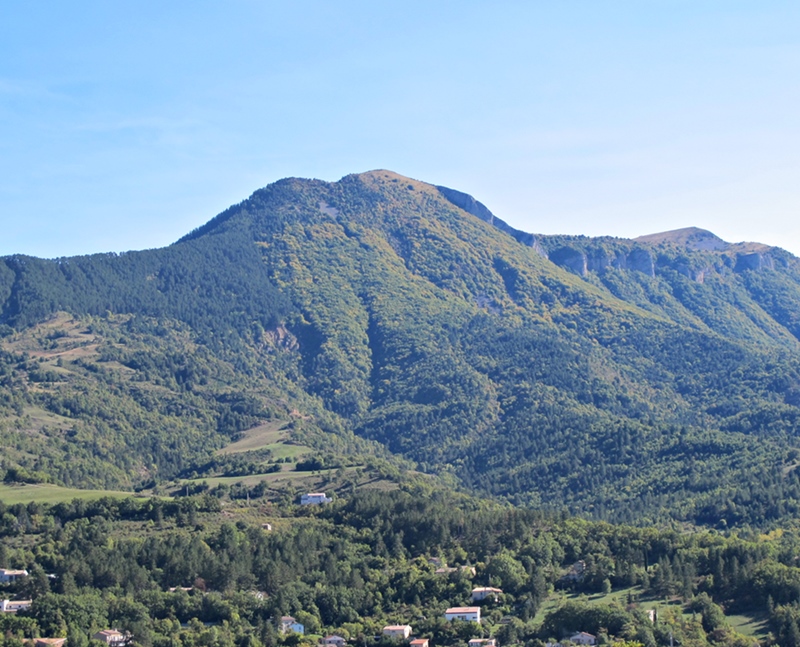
(0, 0, 800, 257)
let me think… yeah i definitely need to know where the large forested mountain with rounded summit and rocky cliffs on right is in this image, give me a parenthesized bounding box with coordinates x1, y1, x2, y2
(0, 171, 800, 525)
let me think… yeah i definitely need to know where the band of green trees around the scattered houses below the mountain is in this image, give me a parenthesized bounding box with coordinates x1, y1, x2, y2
(0, 492, 800, 647)
